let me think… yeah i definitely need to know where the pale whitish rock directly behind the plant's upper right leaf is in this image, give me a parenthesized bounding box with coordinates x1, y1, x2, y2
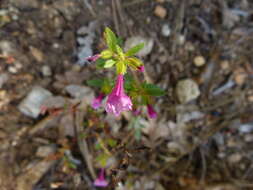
(124, 36, 154, 57)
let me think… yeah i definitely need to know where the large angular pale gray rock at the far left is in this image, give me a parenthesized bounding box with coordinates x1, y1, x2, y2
(18, 86, 52, 118)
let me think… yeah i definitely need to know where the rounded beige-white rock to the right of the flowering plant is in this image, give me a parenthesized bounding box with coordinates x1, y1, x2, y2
(176, 79, 200, 103)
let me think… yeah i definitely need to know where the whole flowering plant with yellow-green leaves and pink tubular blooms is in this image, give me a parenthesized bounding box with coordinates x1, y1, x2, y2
(87, 28, 164, 118)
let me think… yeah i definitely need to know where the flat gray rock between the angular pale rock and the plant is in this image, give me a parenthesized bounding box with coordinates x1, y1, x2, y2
(65, 84, 94, 102)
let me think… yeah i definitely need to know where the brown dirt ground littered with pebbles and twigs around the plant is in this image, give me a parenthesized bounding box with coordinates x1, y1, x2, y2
(0, 0, 253, 190)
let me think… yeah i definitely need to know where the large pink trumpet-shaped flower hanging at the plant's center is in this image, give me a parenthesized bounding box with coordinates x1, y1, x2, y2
(105, 74, 133, 116)
